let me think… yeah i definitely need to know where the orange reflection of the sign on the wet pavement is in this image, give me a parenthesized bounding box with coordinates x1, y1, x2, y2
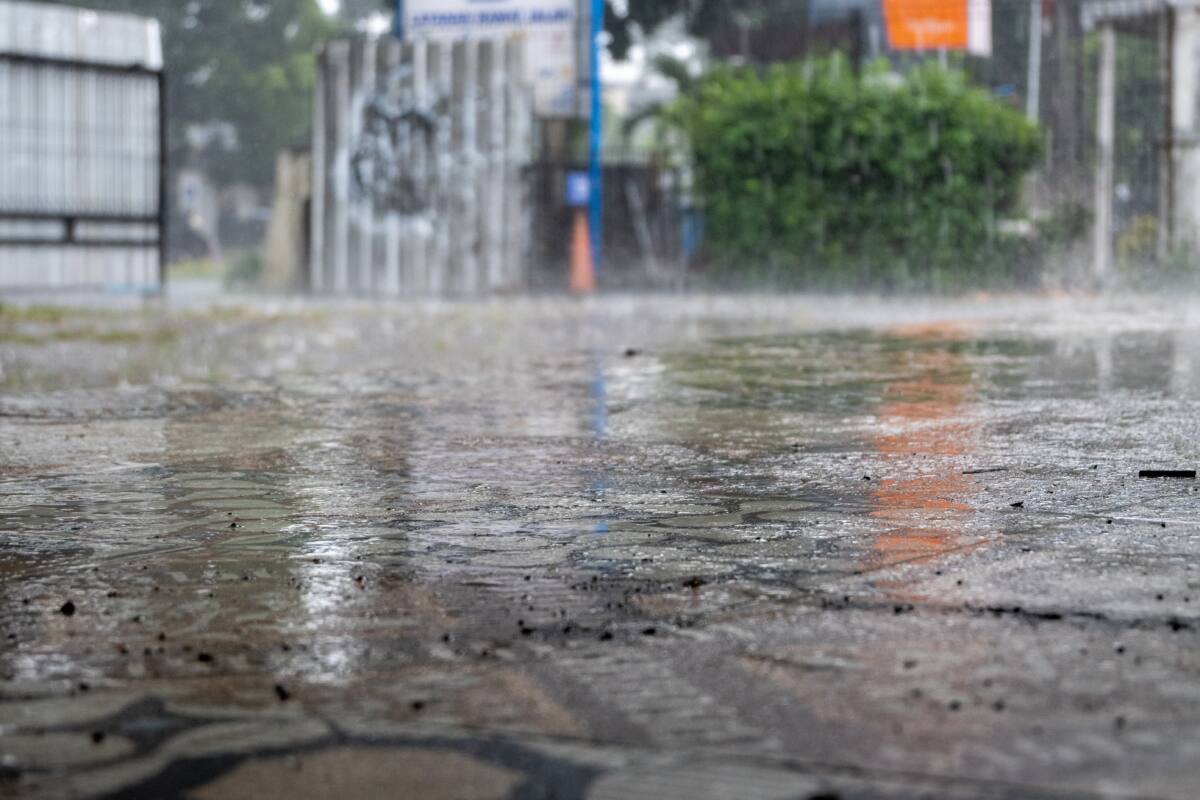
(869, 324, 980, 599)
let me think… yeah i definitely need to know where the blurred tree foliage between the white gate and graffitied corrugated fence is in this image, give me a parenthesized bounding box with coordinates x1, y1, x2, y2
(37, 0, 332, 185)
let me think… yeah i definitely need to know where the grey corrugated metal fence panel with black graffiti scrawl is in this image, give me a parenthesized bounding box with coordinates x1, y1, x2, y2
(310, 37, 532, 296)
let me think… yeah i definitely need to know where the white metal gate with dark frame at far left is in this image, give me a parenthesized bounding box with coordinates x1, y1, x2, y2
(0, 2, 167, 291)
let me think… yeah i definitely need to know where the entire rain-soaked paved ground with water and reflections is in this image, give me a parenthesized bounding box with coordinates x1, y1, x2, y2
(0, 296, 1200, 800)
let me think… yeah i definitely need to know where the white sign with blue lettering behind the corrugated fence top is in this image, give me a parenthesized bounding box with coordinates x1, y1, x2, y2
(400, 0, 577, 116)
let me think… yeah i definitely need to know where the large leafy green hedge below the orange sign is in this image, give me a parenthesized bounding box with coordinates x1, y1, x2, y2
(671, 56, 1040, 288)
